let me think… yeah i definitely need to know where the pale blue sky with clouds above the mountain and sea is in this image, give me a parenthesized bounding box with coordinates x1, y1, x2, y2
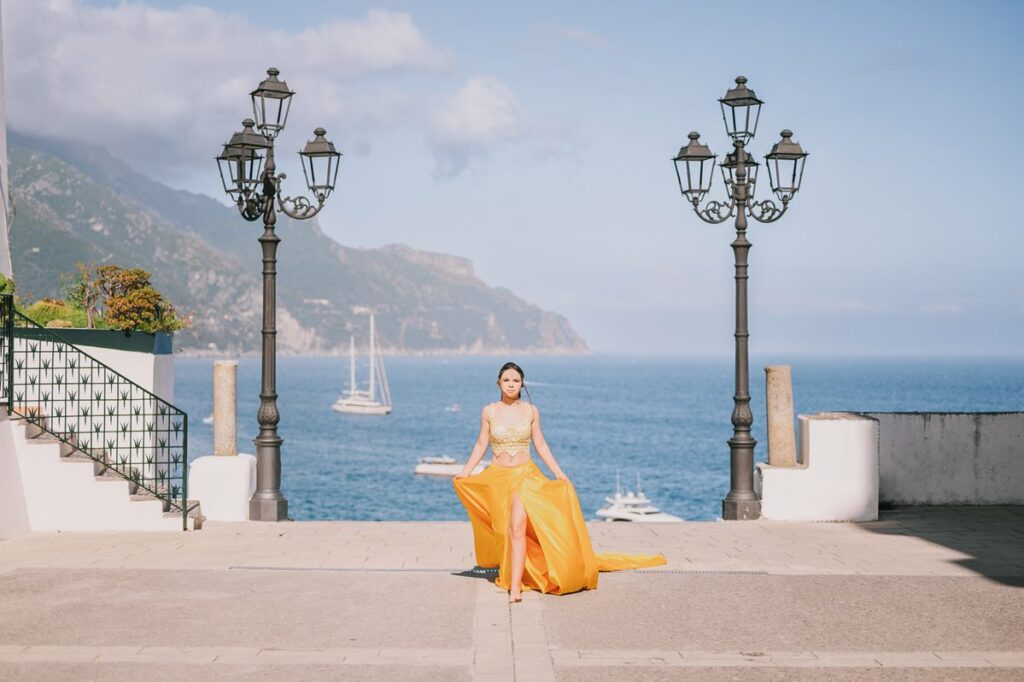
(3, 0, 1024, 355)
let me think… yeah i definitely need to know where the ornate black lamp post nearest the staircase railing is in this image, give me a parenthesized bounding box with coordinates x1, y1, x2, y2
(217, 69, 341, 521)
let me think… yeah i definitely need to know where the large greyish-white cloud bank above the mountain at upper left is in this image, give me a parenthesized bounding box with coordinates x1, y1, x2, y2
(3, 0, 451, 172)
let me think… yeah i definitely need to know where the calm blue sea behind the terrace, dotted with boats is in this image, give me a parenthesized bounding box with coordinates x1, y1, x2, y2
(174, 355, 1024, 520)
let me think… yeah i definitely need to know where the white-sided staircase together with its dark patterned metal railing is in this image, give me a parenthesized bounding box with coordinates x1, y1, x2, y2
(0, 295, 203, 530)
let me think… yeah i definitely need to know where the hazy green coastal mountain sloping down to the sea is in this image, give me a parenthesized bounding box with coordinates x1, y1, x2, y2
(8, 133, 587, 353)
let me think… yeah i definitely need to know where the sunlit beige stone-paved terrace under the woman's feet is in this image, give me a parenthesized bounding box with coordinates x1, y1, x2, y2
(0, 507, 1024, 681)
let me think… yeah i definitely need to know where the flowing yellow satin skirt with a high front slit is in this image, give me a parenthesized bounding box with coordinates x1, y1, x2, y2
(455, 460, 666, 594)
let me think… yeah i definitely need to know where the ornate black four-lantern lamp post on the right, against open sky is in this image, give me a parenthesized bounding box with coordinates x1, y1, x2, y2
(673, 76, 807, 519)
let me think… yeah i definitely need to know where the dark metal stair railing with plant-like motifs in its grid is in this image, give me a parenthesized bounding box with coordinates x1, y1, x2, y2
(0, 294, 189, 529)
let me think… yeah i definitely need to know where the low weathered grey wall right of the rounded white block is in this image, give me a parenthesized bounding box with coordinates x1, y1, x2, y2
(866, 412, 1024, 505)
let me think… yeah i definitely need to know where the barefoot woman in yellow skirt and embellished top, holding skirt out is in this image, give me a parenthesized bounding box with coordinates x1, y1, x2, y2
(454, 363, 666, 602)
